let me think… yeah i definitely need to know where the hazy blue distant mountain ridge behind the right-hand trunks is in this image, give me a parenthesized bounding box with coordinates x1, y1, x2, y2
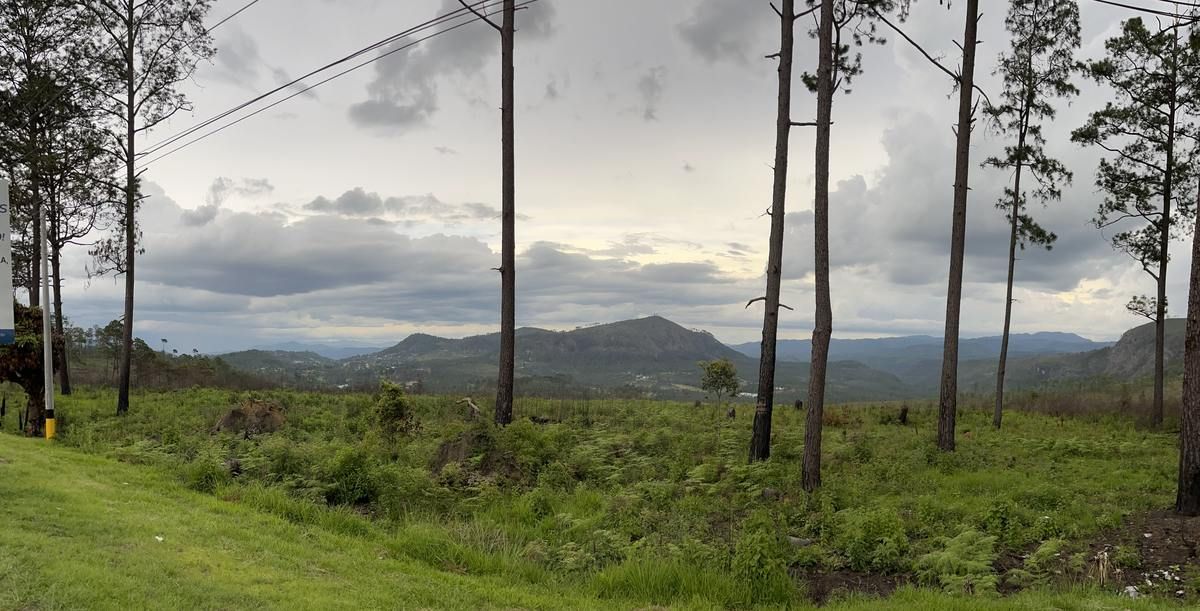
(733, 333, 1113, 395)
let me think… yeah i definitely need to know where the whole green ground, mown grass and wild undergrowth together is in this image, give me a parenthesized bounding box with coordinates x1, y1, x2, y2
(0, 390, 1200, 609)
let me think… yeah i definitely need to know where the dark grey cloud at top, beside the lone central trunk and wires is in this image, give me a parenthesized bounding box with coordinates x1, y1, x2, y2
(350, 0, 554, 130)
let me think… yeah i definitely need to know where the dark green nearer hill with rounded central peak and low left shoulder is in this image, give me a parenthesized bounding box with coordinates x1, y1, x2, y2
(224, 316, 914, 402)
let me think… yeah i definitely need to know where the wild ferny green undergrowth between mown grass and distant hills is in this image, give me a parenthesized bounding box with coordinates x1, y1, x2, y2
(0, 385, 1200, 607)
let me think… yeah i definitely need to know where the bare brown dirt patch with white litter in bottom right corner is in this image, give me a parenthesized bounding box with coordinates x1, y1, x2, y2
(1088, 511, 1200, 598)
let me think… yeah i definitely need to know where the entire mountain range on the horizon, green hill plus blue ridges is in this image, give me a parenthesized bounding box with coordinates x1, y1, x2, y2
(222, 316, 1183, 402)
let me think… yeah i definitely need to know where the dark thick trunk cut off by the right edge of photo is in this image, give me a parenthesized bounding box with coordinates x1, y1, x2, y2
(1175, 183, 1200, 515)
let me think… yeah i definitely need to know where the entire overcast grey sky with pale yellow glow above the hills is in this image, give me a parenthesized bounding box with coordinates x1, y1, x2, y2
(46, 0, 1189, 352)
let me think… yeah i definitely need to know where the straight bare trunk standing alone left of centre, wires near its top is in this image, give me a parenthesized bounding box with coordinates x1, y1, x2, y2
(496, 0, 517, 425)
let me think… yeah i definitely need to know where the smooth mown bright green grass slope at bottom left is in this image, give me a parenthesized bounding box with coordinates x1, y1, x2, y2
(0, 435, 599, 609)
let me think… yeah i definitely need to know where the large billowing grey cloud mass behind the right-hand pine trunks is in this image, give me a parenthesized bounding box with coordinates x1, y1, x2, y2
(785, 114, 1114, 290)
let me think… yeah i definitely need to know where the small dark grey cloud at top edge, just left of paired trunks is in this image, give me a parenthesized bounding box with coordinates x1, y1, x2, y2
(677, 0, 774, 64)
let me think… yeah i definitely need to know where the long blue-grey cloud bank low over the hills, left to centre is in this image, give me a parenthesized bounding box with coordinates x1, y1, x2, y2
(110, 188, 750, 349)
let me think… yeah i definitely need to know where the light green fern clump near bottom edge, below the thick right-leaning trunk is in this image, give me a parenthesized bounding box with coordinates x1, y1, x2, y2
(916, 529, 997, 594)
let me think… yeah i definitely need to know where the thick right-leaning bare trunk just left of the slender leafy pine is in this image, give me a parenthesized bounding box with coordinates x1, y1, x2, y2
(937, 0, 979, 451)
